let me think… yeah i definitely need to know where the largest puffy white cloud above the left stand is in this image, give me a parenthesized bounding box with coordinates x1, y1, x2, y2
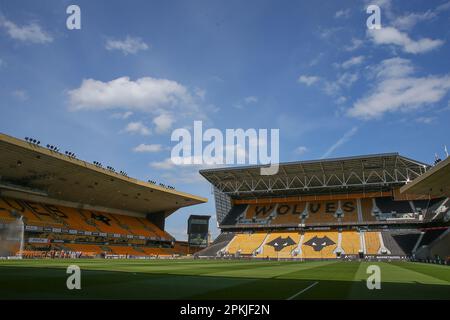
(68, 77, 192, 112)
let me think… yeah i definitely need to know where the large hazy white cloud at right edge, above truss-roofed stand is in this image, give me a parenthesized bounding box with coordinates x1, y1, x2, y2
(347, 58, 450, 119)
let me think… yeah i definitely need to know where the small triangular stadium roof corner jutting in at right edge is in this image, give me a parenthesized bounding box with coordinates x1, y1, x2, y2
(400, 157, 450, 197)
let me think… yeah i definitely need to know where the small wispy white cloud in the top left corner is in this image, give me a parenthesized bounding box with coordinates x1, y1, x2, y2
(0, 15, 53, 44)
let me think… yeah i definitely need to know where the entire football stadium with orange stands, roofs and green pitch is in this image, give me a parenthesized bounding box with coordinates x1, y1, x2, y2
(0, 135, 450, 300)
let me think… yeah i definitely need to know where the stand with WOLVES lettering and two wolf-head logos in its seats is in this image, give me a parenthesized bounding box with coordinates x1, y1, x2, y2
(197, 153, 450, 261)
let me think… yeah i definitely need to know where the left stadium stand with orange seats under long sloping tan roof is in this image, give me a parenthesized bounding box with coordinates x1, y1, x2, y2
(0, 134, 207, 257)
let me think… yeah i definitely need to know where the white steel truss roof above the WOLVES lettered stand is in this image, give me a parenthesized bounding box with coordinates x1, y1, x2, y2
(200, 153, 429, 198)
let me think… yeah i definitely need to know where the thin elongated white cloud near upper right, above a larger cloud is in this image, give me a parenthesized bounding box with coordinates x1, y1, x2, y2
(367, 27, 444, 54)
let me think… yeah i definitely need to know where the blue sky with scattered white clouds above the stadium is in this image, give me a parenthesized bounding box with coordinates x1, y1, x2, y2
(0, 0, 450, 239)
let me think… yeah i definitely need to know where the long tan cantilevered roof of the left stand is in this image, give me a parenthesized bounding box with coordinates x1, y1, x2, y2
(0, 134, 207, 216)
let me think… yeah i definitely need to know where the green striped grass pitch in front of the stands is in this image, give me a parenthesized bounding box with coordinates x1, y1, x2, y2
(0, 260, 450, 300)
